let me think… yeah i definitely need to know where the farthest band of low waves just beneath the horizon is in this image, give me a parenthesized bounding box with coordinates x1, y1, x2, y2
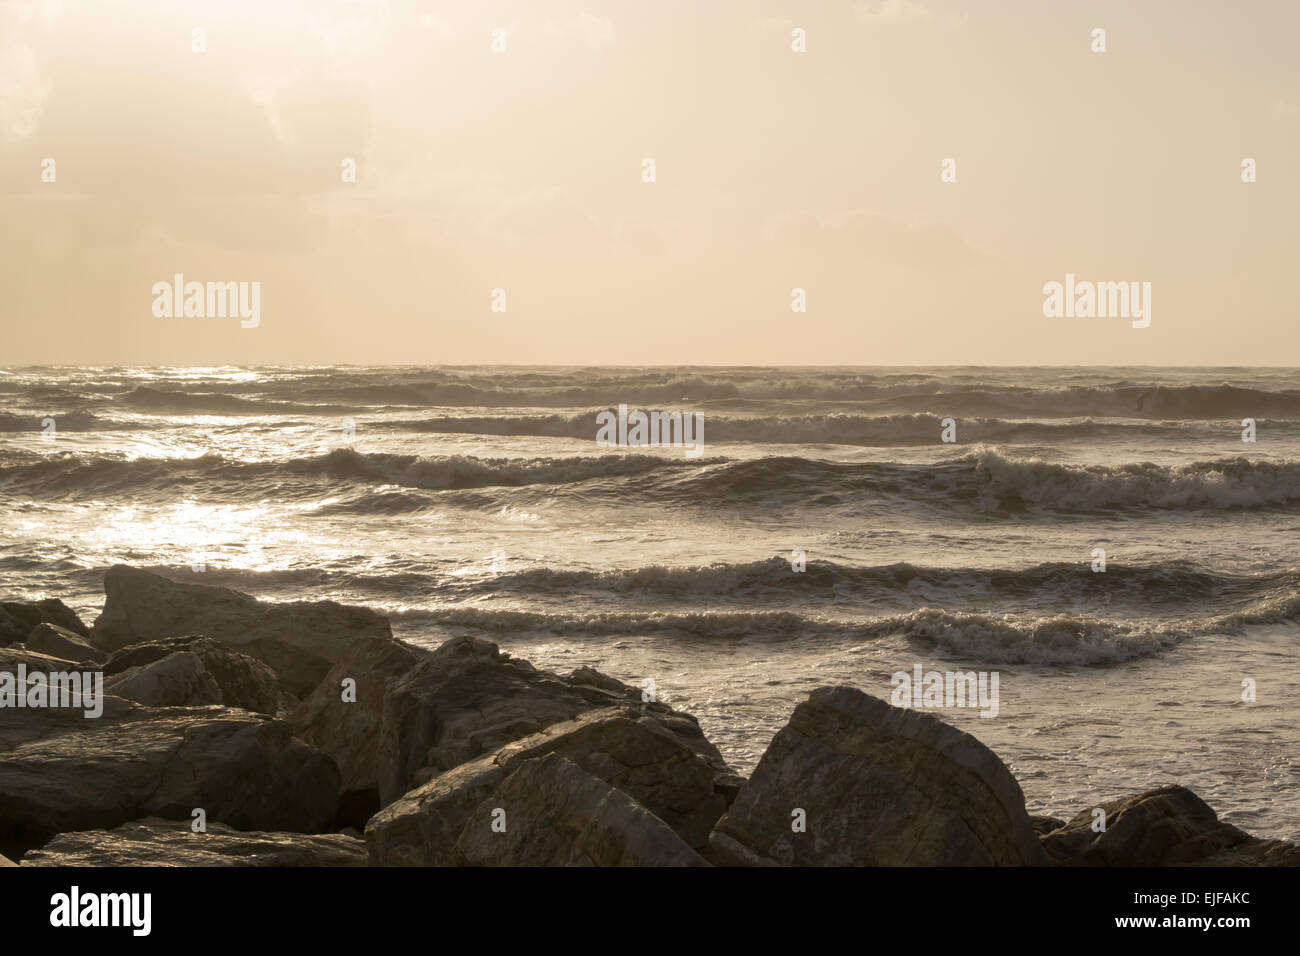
(10, 368, 1300, 420)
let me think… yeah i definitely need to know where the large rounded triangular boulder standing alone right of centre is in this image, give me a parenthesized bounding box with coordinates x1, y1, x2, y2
(706, 687, 1048, 866)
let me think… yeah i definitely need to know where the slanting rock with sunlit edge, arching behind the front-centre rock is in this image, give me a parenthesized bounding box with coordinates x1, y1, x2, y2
(365, 705, 727, 866)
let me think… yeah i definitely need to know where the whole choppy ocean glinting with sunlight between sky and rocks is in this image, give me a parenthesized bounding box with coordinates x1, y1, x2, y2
(0, 367, 1300, 840)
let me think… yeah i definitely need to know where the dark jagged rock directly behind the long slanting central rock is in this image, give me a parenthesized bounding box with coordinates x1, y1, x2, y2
(378, 637, 740, 805)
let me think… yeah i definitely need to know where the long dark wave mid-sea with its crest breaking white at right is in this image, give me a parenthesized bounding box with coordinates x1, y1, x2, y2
(0, 449, 1300, 516)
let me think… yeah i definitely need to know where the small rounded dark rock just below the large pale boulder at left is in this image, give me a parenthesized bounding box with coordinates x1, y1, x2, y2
(104, 636, 282, 715)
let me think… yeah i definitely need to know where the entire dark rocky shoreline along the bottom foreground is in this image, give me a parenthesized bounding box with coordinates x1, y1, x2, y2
(0, 566, 1300, 866)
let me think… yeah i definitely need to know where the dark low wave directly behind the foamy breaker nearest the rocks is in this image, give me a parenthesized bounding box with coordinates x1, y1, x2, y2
(65, 555, 1300, 619)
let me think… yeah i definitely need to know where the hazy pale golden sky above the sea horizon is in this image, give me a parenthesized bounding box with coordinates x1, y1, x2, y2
(0, 0, 1300, 365)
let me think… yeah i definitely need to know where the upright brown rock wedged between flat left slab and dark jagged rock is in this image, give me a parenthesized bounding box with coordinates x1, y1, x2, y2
(286, 639, 429, 827)
